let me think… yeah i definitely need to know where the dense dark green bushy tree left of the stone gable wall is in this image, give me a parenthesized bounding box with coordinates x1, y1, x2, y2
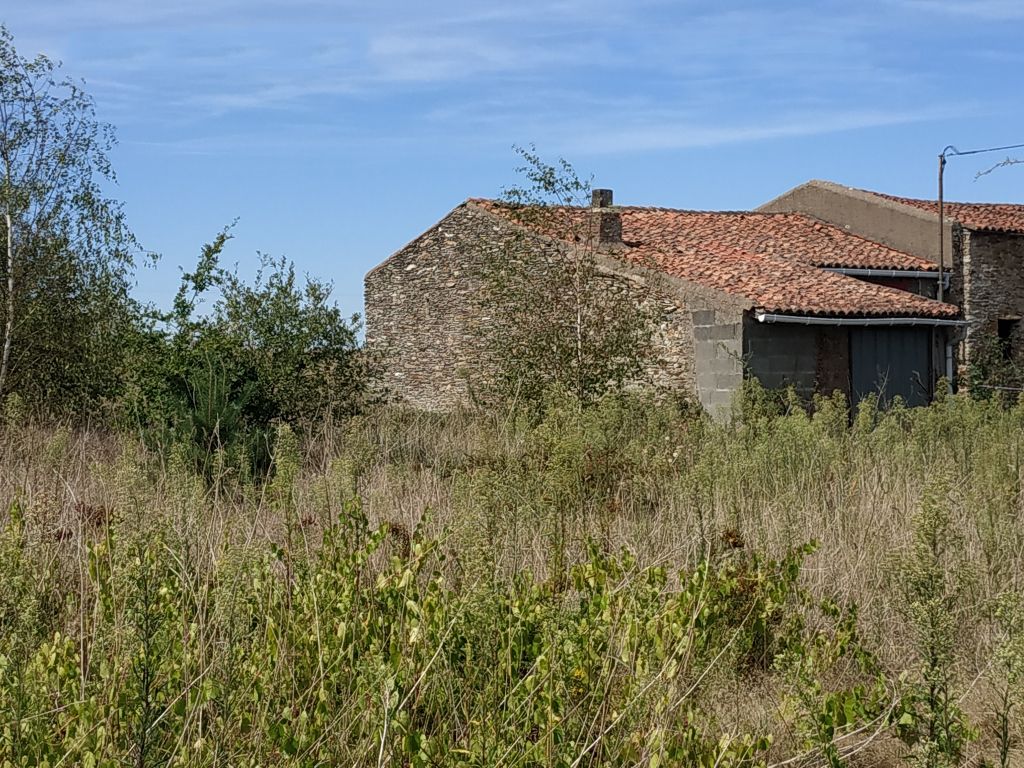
(127, 229, 368, 479)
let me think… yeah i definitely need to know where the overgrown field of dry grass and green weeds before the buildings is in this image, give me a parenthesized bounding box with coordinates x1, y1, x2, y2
(0, 396, 1024, 767)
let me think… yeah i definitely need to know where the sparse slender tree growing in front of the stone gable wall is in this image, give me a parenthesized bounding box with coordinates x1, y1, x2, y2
(481, 147, 653, 403)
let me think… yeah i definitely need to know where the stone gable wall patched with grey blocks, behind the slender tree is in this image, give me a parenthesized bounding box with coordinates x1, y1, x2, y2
(365, 205, 744, 413)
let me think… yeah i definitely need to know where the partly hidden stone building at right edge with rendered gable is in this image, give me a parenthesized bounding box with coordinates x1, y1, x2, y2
(758, 180, 1024, 382)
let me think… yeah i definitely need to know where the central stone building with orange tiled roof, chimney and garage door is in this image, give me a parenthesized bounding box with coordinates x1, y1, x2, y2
(366, 190, 964, 414)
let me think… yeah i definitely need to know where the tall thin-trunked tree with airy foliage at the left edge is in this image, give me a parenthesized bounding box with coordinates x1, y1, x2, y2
(0, 26, 137, 413)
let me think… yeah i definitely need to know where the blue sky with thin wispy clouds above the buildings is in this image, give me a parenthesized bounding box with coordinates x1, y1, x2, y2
(0, 0, 1024, 319)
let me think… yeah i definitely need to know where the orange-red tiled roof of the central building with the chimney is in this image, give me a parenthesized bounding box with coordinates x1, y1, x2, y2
(470, 200, 958, 318)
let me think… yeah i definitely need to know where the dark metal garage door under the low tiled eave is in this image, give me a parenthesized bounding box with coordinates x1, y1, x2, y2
(850, 328, 932, 406)
